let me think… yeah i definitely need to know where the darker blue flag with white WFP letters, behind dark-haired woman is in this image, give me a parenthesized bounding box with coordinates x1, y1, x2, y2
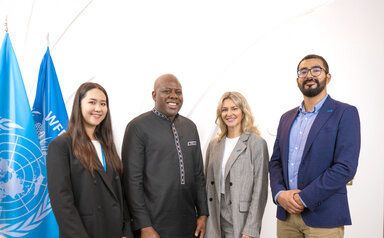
(32, 48, 68, 156)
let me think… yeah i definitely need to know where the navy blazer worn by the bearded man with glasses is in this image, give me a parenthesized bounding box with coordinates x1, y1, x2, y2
(269, 96, 360, 227)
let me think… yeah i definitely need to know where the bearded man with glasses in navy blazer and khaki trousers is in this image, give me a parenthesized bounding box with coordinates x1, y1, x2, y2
(269, 55, 360, 238)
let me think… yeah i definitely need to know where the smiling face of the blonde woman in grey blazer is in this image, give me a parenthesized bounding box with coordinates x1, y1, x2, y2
(221, 98, 243, 135)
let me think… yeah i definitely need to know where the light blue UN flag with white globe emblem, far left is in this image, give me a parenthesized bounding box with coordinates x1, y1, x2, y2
(0, 33, 57, 238)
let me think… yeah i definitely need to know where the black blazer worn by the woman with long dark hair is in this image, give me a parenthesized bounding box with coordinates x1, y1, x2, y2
(47, 133, 133, 238)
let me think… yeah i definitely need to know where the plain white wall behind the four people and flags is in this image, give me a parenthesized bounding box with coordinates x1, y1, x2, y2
(0, 0, 384, 238)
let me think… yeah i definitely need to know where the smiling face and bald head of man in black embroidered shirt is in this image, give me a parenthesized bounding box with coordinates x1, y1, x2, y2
(152, 74, 183, 121)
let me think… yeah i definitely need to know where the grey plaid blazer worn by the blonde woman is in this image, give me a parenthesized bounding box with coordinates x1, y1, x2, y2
(205, 133, 269, 238)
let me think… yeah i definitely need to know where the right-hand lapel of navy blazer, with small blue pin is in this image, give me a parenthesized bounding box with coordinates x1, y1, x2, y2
(302, 96, 335, 159)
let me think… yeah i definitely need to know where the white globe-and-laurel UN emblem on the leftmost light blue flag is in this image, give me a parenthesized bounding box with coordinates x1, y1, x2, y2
(0, 118, 52, 237)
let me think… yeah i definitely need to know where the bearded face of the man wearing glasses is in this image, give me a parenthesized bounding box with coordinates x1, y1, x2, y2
(297, 58, 331, 97)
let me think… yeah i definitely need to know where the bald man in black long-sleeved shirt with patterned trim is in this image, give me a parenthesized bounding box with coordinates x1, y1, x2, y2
(122, 74, 208, 238)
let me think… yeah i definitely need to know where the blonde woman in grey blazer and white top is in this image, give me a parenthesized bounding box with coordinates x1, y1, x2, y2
(205, 92, 268, 238)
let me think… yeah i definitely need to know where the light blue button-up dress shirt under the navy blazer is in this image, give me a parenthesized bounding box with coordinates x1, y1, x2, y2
(275, 94, 328, 207)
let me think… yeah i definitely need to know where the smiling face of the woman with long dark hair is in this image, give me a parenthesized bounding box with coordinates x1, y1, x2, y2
(81, 88, 108, 139)
